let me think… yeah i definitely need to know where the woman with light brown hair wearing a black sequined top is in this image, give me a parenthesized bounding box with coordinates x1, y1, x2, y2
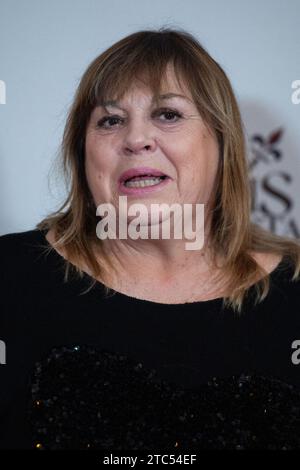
(0, 28, 300, 449)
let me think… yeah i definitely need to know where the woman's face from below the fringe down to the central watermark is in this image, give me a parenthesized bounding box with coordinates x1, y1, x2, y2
(85, 69, 219, 228)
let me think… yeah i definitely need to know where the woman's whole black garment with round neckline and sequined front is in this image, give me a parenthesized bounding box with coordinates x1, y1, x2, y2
(0, 230, 300, 451)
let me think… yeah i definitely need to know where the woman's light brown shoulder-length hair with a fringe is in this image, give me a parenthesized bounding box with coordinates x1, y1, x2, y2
(37, 28, 300, 312)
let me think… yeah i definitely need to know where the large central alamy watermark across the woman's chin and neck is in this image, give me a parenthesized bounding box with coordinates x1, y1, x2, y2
(96, 196, 204, 250)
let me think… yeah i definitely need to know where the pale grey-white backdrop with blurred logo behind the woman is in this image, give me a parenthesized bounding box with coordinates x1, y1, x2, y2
(0, 0, 300, 236)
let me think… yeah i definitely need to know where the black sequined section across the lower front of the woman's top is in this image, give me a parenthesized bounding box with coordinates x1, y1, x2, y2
(28, 345, 300, 451)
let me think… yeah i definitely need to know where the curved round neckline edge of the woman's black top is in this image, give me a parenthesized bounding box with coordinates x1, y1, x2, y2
(36, 229, 286, 307)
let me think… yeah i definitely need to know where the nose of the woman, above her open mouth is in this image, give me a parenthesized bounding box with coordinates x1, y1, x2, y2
(124, 118, 156, 155)
